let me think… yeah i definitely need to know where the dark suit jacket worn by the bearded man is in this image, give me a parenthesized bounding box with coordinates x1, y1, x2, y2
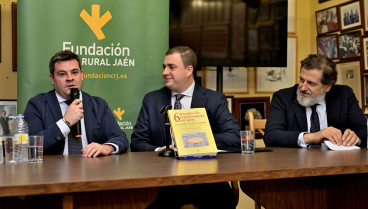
(264, 85, 367, 147)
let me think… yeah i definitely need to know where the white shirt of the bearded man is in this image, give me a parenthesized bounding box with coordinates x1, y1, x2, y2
(298, 99, 328, 147)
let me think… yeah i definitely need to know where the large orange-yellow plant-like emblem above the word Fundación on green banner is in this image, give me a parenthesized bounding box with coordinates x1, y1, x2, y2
(79, 4, 112, 40)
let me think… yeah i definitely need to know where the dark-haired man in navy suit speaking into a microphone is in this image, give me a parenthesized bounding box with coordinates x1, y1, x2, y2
(24, 51, 129, 157)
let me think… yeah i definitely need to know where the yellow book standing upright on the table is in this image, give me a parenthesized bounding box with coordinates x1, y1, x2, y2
(168, 108, 218, 158)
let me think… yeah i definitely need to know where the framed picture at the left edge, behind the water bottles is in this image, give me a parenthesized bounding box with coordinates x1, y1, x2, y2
(0, 100, 17, 135)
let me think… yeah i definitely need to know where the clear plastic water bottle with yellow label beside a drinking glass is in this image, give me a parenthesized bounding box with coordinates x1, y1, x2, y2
(14, 114, 29, 163)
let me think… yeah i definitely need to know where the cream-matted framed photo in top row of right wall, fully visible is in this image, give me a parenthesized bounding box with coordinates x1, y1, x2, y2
(339, 1, 362, 31)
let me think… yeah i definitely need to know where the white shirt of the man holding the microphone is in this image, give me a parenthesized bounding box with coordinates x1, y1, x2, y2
(55, 91, 119, 155)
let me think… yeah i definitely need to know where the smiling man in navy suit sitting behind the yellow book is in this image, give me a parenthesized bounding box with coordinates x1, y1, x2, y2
(130, 46, 240, 208)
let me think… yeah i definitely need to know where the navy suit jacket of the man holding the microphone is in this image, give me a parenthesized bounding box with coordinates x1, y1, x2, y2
(24, 90, 129, 155)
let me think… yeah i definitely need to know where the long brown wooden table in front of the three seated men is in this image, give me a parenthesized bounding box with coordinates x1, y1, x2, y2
(0, 148, 368, 208)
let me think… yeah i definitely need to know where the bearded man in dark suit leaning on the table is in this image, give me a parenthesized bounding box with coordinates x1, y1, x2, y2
(264, 55, 367, 147)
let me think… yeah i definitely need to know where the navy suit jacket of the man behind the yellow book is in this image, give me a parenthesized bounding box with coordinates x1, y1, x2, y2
(130, 84, 240, 151)
